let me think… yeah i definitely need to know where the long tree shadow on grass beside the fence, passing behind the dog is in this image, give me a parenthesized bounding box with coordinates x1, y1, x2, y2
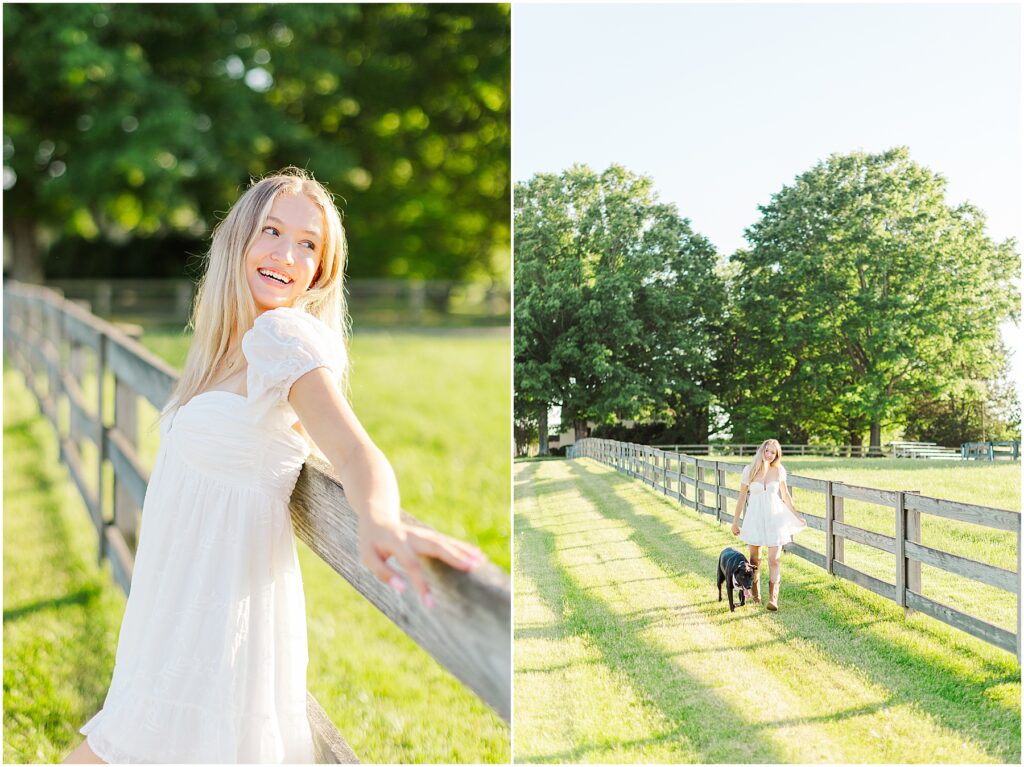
(569, 461, 1021, 763)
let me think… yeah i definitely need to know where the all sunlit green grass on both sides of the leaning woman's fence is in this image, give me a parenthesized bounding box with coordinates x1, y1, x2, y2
(4, 331, 511, 763)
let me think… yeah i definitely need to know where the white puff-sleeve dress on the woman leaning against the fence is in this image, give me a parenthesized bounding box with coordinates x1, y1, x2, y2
(80, 308, 345, 763)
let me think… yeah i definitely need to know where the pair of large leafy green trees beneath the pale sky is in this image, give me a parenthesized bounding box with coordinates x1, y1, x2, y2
(514, 147, 1020, 452)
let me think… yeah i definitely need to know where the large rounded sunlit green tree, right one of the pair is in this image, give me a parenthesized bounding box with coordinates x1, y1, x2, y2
(725, 147, 1020, 448)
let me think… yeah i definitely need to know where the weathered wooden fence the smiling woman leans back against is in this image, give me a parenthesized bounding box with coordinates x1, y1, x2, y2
(3, 281, 512, 763)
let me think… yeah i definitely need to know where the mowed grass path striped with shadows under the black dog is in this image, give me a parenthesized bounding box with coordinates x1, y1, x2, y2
(514, 460, 1021, 763)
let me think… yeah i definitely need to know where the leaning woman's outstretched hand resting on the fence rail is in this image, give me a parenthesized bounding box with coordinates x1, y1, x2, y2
(359, 516, 485, 607)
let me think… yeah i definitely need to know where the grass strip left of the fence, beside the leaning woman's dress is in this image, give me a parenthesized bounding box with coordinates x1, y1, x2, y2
(3, 370, 125, 763)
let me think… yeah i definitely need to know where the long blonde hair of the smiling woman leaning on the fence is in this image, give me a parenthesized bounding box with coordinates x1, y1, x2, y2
(161, 166, 348, 417)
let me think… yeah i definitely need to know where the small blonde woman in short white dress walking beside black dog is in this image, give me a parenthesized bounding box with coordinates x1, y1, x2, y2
(732, 439, 807, 610)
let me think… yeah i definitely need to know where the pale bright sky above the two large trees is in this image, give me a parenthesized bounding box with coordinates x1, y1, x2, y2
(512, 4, 1024, 371)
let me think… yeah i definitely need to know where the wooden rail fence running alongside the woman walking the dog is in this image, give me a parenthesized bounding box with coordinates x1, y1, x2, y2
(568, 438, 1021, 661)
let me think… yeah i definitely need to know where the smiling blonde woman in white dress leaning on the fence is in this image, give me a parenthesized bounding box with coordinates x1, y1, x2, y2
(66, 168, 483, 763)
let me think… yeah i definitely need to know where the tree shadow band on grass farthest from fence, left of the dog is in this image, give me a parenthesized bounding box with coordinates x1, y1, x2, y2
(515, 505, 783, 762)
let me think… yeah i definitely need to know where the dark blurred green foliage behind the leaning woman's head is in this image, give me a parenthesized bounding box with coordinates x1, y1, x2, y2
(3, 4, 510, 281)
